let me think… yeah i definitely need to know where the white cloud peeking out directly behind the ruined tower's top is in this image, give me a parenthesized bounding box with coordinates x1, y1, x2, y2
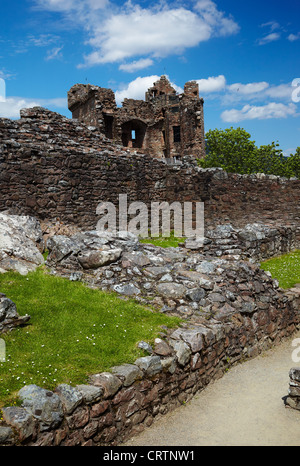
(115, 75, 183, 105)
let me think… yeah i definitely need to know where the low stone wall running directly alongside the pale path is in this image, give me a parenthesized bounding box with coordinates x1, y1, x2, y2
(0, 284, 299, 446)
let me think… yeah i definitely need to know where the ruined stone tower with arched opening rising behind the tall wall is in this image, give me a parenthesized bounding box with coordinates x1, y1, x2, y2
(68, 76, 205, 159)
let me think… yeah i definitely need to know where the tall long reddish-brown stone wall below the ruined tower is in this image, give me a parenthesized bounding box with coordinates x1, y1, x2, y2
(0, 108, 300, 235)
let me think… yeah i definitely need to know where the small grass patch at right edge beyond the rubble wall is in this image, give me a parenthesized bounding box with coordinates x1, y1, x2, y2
(261, 250, 300, 289)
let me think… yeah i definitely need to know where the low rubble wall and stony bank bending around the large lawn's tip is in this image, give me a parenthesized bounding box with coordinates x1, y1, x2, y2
(0, 222, 300, 446)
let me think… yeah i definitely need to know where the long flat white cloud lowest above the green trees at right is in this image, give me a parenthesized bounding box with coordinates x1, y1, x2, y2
(221, 102, 297, 123)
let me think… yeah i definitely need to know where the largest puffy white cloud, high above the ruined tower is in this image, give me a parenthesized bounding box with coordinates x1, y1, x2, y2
(81, 6, 212, 65)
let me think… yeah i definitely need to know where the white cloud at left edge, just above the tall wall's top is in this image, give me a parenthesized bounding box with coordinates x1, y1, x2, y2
(0, 97, 67, 119)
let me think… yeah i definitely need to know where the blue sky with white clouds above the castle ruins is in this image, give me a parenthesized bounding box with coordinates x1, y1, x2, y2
(0, 0, 300, 155)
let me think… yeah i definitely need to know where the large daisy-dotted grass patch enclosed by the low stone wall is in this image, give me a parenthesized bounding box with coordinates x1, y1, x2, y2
(0, 268, 180, 406)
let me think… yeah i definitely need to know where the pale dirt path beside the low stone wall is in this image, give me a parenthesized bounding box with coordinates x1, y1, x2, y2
(125, 334, 300, 446)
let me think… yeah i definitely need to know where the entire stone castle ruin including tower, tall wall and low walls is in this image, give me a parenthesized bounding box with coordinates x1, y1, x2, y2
(0, 85, 300, 446)
